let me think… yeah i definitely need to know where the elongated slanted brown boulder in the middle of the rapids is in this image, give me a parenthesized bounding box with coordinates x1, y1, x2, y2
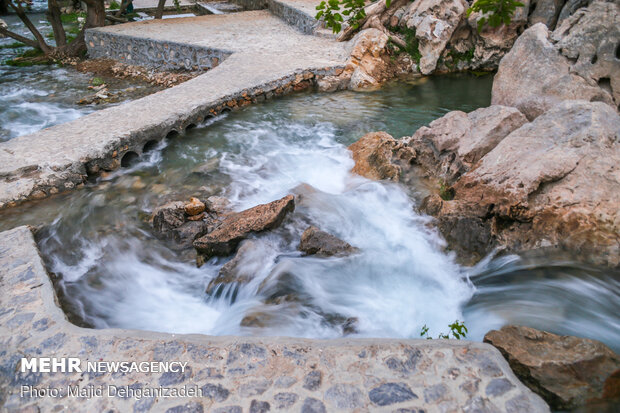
(194, 195, 295, 258)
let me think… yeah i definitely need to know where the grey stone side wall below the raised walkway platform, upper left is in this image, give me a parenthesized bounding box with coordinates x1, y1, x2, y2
(85, 30, 232, 70)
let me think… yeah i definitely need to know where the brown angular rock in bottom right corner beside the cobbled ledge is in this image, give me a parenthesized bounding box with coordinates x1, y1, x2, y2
(484, 325, 620, 410)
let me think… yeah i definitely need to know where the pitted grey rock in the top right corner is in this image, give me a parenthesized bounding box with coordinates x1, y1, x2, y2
(551, 1, 620, 107)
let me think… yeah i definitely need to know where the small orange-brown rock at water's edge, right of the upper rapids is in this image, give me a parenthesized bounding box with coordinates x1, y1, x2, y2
(349, 132, 413, 182)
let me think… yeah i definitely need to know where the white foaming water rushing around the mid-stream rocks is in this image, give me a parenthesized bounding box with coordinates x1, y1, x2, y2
(47, 118, 473, 337)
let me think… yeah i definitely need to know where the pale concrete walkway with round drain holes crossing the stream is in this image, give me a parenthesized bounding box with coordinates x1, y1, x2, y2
(0, 10, 347, 208)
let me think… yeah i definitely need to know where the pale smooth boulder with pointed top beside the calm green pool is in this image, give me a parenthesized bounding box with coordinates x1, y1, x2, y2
(491, 23, 614, 120)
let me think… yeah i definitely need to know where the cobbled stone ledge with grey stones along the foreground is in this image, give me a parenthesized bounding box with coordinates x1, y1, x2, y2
(0, 227, 548, 413)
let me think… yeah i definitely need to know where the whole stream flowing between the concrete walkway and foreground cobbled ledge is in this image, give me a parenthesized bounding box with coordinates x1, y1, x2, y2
(0, 75, 620, 350)
